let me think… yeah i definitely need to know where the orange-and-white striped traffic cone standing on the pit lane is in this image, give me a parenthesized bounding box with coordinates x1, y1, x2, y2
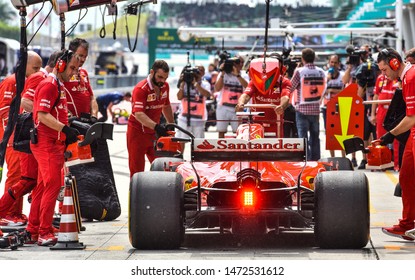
(50, 186, 86, 250)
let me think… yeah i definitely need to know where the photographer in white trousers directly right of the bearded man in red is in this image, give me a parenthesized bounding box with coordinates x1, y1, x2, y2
(176, 65, 210, 148)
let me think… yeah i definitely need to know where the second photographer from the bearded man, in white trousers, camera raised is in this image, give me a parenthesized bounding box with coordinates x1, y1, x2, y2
(215, 56, 248, 138)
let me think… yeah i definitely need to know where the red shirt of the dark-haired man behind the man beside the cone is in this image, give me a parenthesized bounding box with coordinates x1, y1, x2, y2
(65, 68, 94, 117)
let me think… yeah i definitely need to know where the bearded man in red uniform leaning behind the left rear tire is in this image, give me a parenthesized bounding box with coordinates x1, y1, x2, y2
(127, 60, 174, 177)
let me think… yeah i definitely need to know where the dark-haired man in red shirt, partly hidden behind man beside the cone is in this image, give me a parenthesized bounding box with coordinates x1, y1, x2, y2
(65, 38, 98, 118)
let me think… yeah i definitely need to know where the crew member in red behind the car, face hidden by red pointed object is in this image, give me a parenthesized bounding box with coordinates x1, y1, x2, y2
(235, 55, 291, 137)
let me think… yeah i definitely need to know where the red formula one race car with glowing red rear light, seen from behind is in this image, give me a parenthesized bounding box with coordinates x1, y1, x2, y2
(129, 108, 370, 249)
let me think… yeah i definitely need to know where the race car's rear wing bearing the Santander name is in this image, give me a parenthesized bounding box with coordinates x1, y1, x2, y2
(191, 138, 307, 162)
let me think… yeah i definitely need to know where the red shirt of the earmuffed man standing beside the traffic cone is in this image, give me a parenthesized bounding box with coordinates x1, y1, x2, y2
(33, 74, 68, 141)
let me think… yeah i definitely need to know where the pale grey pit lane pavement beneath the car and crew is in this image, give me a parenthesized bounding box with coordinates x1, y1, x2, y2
(0, 125, 415, 261)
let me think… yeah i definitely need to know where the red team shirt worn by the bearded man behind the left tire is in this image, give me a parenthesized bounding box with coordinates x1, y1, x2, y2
(129, 76, 170, 134)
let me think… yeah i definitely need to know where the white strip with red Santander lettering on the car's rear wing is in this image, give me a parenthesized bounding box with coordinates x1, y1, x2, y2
(194, 138, 304, 152)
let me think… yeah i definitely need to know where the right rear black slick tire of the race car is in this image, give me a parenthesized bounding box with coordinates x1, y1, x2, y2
(314, 171, 370, 249)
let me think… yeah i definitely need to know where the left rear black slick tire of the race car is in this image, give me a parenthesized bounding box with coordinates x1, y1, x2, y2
(128, 171, 184, 249)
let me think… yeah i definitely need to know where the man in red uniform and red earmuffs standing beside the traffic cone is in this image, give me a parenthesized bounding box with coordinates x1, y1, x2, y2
(27, 51, 79, 246)
